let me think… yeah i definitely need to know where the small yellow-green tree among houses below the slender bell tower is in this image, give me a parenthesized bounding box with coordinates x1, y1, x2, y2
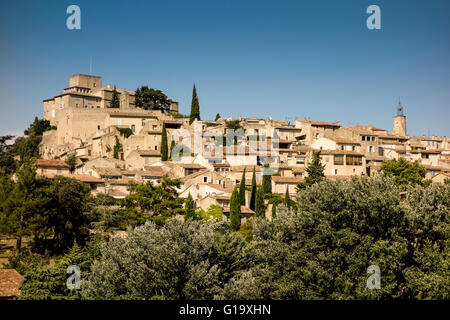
(380, 158, 426, 190)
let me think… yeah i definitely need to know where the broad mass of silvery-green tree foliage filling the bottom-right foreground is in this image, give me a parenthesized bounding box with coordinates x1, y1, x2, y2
(83, 175, 450, 299)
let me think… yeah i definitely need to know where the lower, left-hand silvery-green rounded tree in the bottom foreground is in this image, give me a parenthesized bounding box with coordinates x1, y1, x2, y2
(82, 219, 247, 300)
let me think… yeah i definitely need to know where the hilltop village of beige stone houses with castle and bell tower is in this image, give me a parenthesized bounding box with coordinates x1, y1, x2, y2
(36, 74, 450, 215)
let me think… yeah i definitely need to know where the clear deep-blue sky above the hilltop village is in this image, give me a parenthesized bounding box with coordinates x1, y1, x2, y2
(0, 0, 450, 136)
